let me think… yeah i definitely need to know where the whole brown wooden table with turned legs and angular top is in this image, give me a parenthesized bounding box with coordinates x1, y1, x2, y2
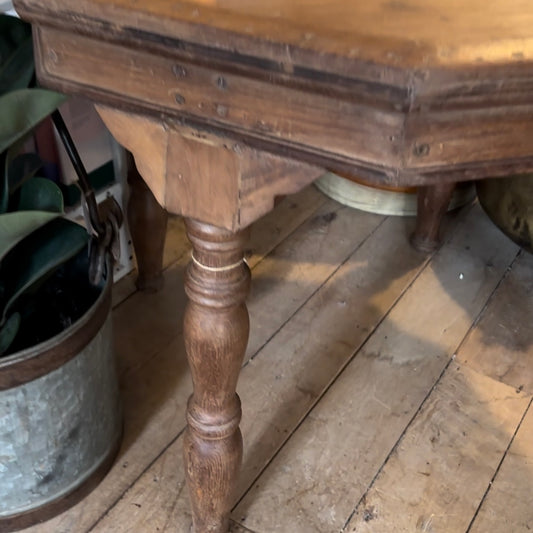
(15, 0, 533, 533)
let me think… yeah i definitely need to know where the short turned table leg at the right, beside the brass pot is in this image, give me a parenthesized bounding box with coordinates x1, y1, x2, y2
(411, 183, 455, 253)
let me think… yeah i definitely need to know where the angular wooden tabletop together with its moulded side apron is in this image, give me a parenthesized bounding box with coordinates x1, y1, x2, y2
(15, 0, 533, 192)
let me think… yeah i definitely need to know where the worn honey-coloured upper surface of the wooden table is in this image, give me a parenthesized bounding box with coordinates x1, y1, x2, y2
(18, 0, 533, 66)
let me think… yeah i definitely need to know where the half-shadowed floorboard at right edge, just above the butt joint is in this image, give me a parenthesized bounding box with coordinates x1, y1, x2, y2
(459, 248, 533, 393)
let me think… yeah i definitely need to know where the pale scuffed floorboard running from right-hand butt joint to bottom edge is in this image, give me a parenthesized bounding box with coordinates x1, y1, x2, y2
(346, 363, 529, 533)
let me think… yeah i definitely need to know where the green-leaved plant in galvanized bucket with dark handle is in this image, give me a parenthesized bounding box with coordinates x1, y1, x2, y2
(0, 15, 121, 531)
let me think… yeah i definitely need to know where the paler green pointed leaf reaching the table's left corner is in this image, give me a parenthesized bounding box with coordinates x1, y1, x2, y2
(0, 89, 65, 152)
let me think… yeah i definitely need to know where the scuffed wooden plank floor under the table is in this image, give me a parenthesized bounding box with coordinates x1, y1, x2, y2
(25, 188, 533, 533)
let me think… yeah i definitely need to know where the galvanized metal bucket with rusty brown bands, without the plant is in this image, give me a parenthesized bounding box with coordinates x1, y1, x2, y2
(0, 268, 122, 531)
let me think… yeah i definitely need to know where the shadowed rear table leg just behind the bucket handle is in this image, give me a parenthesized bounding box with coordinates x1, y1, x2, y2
(127, 152, 168, 291)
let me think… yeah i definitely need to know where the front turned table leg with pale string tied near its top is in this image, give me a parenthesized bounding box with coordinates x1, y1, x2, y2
(184, 219, 250, 533)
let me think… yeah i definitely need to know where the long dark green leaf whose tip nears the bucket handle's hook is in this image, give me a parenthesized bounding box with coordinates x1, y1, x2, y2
(0, 218, 88, 323)
